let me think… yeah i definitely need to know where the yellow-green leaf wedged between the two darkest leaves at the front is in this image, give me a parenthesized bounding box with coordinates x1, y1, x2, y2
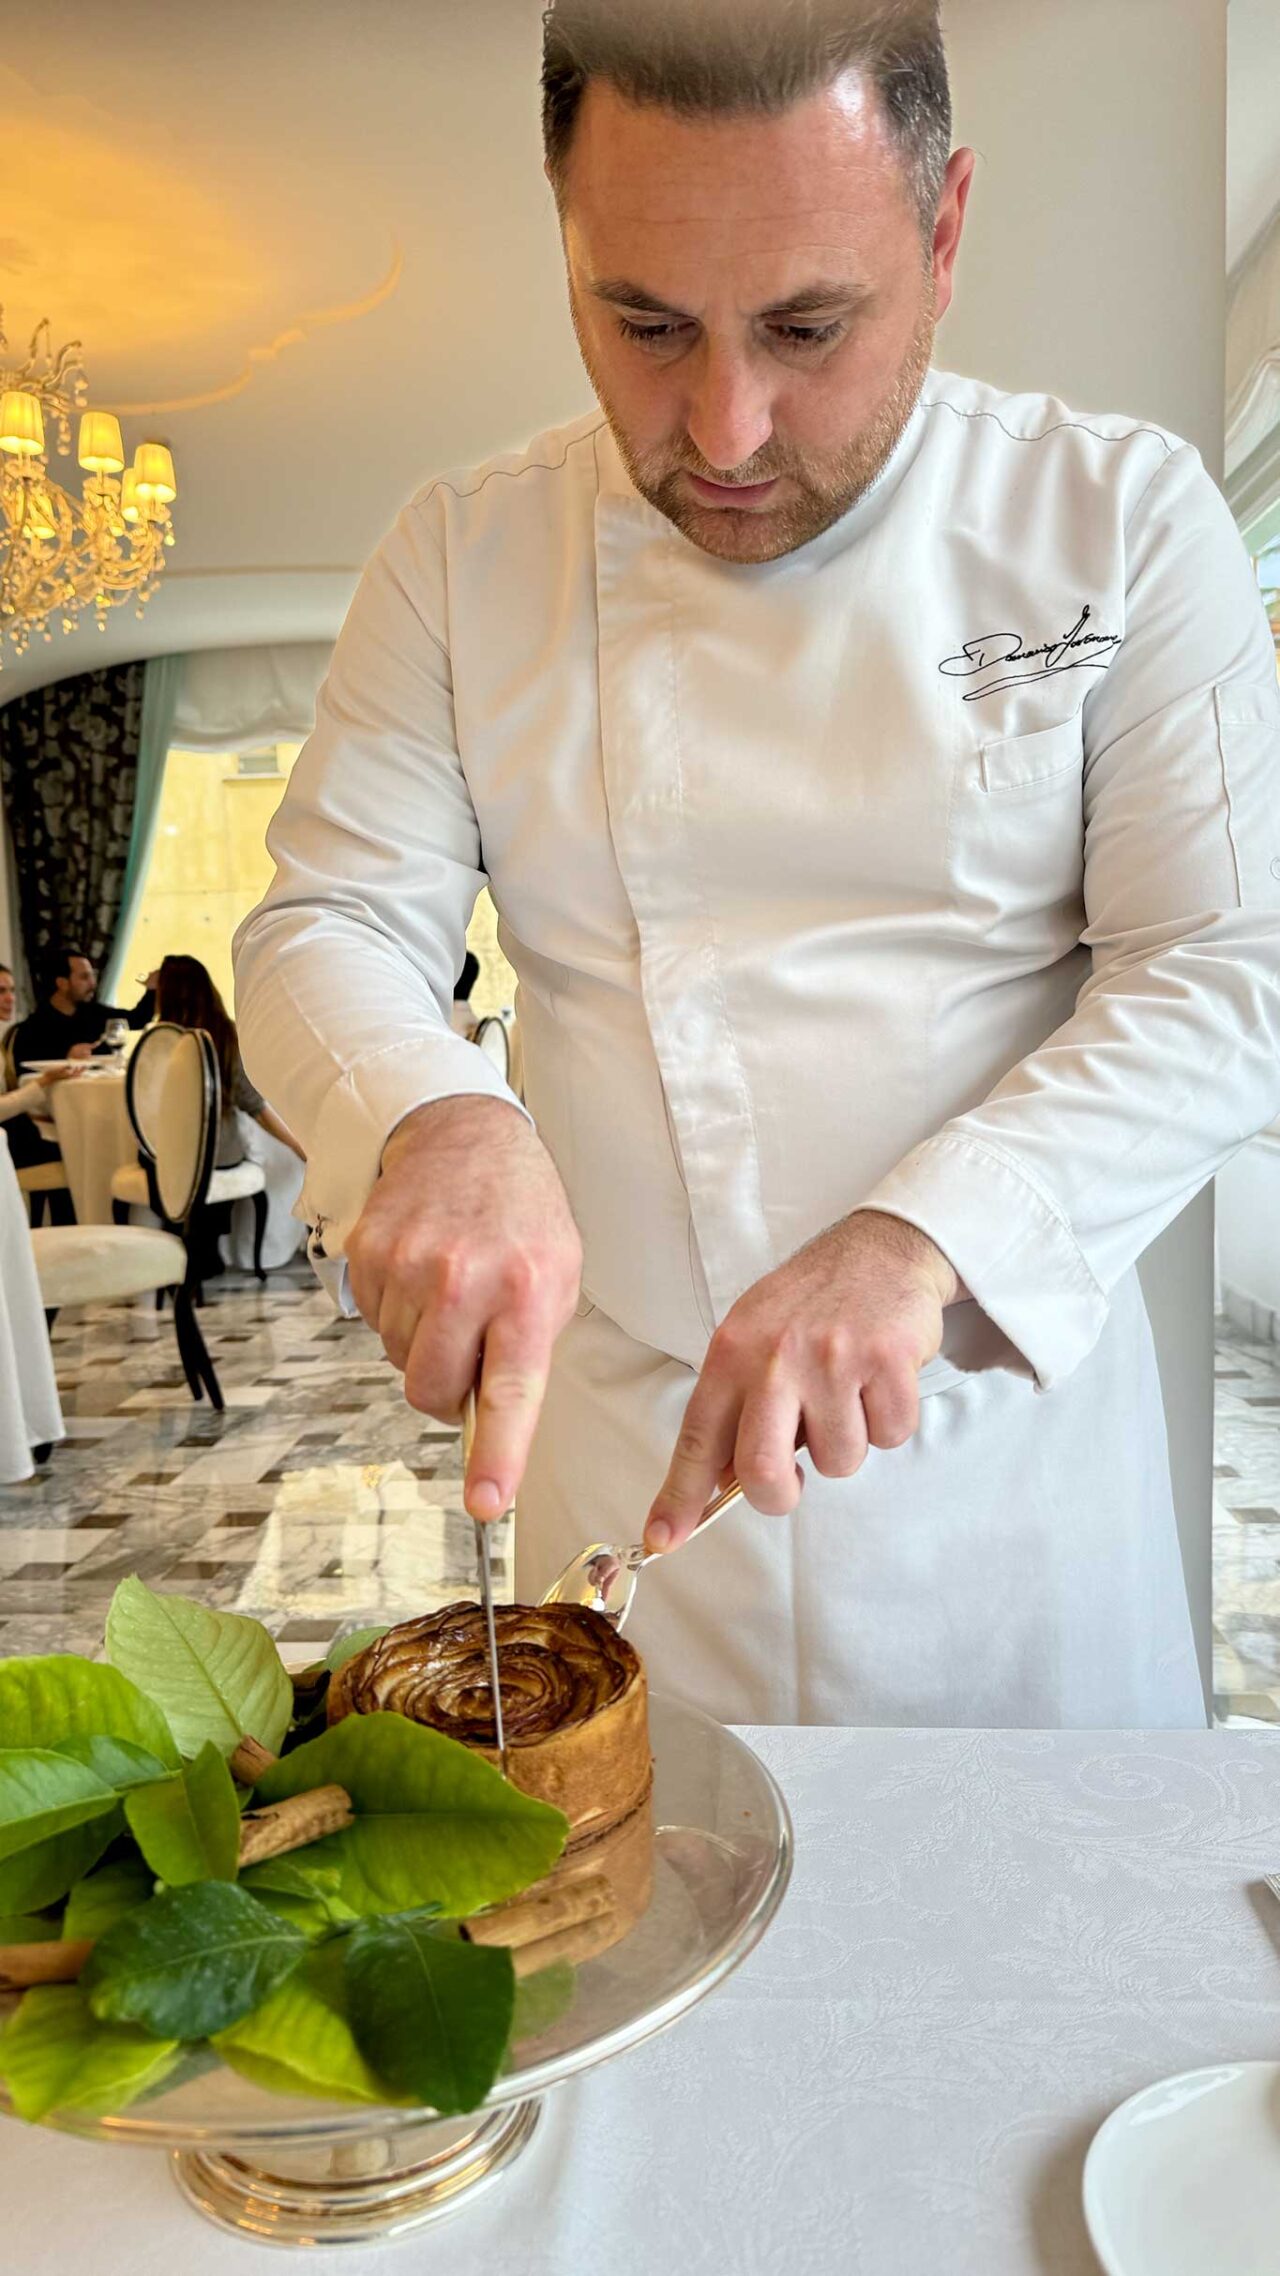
(214, 1939, 394, 2103)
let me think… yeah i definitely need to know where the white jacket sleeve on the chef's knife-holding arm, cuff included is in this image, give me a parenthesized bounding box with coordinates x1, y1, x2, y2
(235, 492, 524, 1256)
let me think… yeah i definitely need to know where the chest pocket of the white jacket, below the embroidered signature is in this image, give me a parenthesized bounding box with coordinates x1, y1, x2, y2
(947, 719, 1084, 937)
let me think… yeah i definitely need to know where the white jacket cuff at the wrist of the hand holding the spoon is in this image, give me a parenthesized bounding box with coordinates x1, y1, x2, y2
(859, 1131, 1109, 1391)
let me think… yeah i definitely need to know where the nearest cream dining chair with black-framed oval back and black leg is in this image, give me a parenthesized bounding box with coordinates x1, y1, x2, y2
(32, 1029, 223, 1409)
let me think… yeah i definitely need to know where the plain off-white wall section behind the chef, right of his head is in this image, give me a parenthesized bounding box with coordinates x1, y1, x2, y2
(938, 0, 1228, 1711)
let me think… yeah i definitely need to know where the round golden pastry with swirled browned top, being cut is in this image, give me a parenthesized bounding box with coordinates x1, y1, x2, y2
(326, 1605, 654, 1846)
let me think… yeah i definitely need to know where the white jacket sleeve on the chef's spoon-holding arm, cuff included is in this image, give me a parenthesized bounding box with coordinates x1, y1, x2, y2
(861, 446, 1280, 1388)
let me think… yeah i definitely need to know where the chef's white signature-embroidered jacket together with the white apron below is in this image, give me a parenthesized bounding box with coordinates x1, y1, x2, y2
(237, 371, 1280, 1725)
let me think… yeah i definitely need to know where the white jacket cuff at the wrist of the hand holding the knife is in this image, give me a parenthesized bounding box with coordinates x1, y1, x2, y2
(296, 1033, 533, 1259)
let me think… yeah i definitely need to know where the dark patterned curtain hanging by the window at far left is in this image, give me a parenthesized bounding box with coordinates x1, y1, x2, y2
(0, 662, 146, 979)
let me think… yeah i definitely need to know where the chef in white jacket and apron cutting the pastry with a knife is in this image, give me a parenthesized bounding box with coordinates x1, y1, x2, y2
(239, 0, 1280, 1725)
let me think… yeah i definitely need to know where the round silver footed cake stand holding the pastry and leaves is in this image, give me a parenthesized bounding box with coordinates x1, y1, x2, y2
(0, 1698, 790, 2246)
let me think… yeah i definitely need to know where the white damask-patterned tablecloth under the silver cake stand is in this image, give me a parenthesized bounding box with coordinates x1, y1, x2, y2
(0, 1730, 1280, 2276)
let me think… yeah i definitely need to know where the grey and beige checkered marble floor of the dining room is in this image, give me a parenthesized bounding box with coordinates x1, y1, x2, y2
(0, 1263, 1280, 1723)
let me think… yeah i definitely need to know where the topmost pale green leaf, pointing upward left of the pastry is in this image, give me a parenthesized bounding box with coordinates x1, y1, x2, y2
(107, 1577, 294, 1755)
